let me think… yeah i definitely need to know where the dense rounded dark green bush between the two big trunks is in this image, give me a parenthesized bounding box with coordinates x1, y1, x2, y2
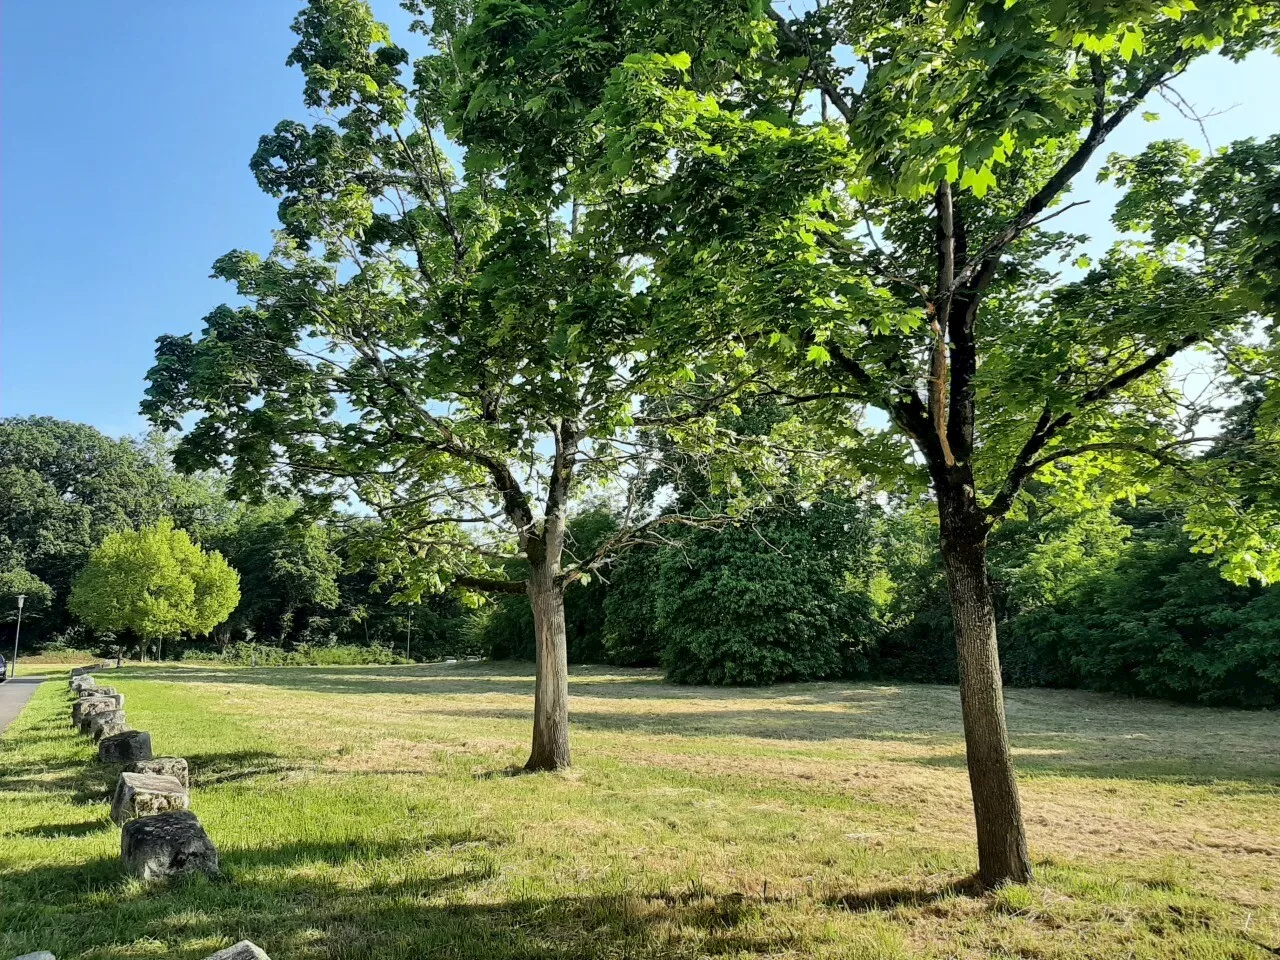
(655, 504, 874, 685)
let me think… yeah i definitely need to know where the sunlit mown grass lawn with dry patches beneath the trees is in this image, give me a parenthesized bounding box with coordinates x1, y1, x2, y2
(0, 664, 1280, 960)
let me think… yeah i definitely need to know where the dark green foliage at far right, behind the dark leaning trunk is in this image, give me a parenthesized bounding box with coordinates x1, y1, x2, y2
(873, 508, 1280, 707)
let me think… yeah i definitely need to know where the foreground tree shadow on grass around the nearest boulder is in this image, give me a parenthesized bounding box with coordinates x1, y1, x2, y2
(0, 832, 803, 960)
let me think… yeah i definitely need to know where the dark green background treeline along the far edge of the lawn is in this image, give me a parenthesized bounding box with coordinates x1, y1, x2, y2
(0, 417, 1280, 707)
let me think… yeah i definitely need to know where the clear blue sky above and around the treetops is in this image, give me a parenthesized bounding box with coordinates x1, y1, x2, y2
(0, 0, 1280, 434)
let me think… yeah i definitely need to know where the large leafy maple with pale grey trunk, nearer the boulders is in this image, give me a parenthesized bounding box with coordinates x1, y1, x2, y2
(143, 0, 757, 771)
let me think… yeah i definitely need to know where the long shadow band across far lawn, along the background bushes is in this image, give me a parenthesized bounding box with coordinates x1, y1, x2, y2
(115, 663, 1280, 792)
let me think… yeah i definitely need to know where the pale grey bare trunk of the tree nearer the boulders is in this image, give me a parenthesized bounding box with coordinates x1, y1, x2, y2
(525, 557, 570, 771)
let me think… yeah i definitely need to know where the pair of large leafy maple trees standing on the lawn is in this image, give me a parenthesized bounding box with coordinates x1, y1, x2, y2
(143, 0, 1280, 884)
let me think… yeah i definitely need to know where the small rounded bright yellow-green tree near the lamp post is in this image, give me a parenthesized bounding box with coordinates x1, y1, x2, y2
(70, 520, 239, 660)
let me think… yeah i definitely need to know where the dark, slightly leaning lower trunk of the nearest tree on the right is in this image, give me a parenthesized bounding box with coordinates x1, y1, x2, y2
(938, 484, 1032, 888)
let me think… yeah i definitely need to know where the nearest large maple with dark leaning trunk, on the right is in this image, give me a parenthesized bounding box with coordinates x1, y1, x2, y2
(448, 0, 1280, 886)
